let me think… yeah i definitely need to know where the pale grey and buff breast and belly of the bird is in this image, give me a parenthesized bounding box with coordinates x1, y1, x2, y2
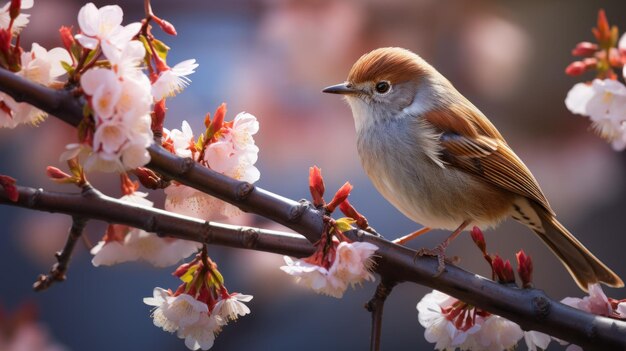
(357, 117, 513, 230)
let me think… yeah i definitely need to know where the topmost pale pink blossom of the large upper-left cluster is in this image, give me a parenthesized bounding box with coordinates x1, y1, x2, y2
(76, 3, 141, 52)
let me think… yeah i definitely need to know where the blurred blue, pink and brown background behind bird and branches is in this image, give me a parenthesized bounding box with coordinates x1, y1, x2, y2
(0, 0, 626, 351)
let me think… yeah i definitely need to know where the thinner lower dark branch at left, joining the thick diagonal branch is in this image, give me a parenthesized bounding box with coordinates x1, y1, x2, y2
(0, 186, 313, 257)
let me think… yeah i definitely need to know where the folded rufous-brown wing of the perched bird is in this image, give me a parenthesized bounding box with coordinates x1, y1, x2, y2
(422, 102, 554, 214)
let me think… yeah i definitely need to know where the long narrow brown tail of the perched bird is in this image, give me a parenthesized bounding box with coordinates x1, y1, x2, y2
(531, 204, 624, 291)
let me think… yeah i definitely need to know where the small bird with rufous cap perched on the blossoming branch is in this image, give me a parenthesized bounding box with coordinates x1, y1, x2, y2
(322, 47, 624, 291)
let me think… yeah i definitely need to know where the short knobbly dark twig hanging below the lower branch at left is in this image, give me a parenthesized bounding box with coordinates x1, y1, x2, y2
(33, 216, 87, 291)
